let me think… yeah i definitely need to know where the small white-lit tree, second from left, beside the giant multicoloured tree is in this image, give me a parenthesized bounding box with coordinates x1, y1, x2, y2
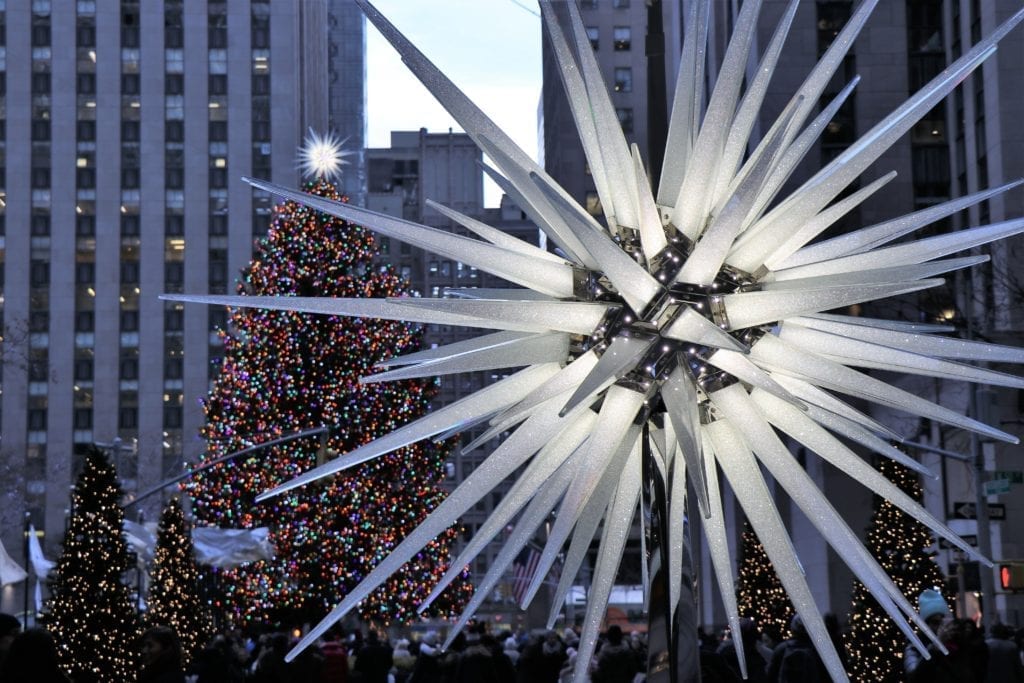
(145, 500, 212, 665)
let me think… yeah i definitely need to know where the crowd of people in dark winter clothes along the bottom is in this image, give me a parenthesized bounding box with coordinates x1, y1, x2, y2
(6, 590, 1024, 683)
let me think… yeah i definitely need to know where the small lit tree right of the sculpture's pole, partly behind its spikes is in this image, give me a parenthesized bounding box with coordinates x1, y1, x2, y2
(736, 520, 797, 642)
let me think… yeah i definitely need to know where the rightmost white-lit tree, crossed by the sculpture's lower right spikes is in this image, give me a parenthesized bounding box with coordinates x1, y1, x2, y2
(846, 459, 949, 683)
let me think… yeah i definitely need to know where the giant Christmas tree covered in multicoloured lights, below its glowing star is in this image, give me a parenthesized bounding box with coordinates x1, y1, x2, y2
(186, 152, 471, 623)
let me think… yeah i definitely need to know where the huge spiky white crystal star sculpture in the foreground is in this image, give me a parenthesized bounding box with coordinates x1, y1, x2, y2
(165, 0, 1024, 681)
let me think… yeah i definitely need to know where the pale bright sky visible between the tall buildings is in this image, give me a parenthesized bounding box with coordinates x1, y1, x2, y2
(367, 0, 541, 206)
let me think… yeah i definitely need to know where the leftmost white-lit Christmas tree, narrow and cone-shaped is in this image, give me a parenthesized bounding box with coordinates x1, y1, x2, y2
(43, 449, 141, 683)
